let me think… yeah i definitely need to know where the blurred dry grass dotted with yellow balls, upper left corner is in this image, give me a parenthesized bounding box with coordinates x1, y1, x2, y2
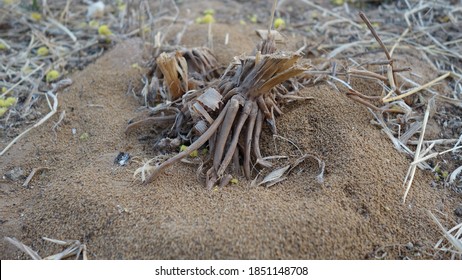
(0, 0, 178, 133)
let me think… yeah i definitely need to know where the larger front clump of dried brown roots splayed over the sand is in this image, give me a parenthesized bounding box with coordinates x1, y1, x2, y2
(141, 42, 307, 188)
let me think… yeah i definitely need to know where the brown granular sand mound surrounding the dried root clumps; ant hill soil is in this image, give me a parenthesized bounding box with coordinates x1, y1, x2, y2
(0, 24, 456, 259)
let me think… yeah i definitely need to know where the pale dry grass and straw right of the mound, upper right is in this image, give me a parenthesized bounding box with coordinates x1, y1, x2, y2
(294, 0, 462, 195)
